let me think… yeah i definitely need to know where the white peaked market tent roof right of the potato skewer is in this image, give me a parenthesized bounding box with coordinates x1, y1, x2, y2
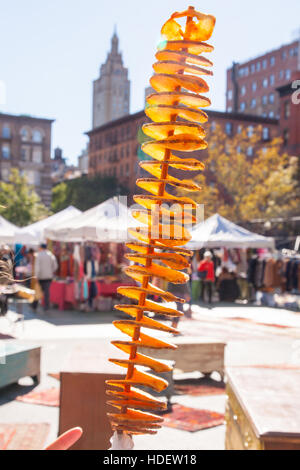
(186, 214, 275, 250)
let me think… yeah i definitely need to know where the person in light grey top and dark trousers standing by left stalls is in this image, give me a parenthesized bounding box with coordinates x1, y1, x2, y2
(35, 243, 58, 310)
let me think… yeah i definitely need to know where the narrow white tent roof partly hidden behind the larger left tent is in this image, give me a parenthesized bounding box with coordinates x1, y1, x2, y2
(14, 206, 82, 245)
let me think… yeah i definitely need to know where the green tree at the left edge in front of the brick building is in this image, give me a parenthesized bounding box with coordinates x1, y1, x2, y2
(0, 168, 50, 227)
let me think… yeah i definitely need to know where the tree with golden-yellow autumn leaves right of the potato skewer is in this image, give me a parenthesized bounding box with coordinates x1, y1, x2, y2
(188, 128, 300, 223)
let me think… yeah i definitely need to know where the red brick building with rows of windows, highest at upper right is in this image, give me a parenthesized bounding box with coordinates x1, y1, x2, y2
(226, 41, 300, 119)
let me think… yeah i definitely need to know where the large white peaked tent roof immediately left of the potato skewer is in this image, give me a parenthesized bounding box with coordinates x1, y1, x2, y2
(45, 197, 140, 243)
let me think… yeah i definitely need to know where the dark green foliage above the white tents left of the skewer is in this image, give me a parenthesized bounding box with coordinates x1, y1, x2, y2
(52, 175, 129, 212)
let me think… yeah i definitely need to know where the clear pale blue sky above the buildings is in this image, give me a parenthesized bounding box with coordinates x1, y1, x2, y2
(0, 0, 300, 162)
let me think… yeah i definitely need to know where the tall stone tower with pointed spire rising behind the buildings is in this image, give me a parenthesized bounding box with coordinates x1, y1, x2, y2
(93, 30, 130, 128)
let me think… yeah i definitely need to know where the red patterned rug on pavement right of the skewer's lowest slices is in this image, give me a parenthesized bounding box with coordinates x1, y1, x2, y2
(162, 403, 224, 432)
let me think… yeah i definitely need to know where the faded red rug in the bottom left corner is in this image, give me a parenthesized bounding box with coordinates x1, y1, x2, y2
(0, 423, 50, 450)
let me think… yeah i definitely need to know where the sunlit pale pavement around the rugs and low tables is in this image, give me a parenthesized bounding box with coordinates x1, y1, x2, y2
(0, 304, 300, 450)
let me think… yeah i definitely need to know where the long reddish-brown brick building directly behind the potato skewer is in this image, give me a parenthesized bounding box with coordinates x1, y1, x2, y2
(87, 111, 278, 192)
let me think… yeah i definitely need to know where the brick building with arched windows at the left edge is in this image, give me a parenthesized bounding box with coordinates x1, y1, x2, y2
(0, 113, 53, 206)
